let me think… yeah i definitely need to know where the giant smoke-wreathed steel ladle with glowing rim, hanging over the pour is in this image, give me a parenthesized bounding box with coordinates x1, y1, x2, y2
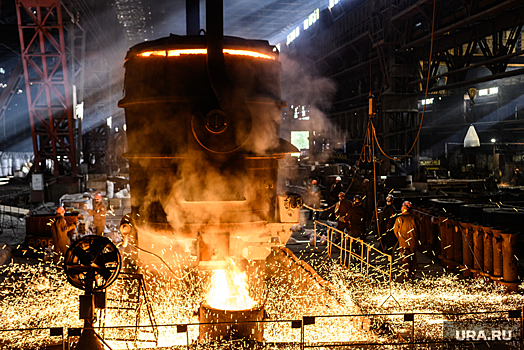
(119, 1, 302, 269)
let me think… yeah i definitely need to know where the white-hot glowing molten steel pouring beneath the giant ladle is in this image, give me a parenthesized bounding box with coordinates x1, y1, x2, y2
(206, 270, 257, 310)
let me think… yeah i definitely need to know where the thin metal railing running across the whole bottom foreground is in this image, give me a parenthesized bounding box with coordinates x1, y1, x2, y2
(0, 307, 524, 350)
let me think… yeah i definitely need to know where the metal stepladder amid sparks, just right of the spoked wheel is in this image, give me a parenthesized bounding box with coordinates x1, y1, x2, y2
(99, 272, 158, 347)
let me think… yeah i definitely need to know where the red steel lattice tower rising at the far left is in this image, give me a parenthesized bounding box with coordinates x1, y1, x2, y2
(16, 0, 77, 176)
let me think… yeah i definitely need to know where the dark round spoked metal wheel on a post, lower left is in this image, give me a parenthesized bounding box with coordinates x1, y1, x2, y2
(64, 235, 122, 291)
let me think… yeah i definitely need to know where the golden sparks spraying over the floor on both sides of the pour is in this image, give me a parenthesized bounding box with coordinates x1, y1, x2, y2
(0, 247, 524, 349)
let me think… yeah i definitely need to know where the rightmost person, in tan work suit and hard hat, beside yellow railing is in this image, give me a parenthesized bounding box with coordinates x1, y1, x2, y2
(393, 201, 422, 280)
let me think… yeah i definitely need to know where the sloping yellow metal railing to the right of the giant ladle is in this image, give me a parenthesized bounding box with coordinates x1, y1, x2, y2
(313, 221, 398, 303)
